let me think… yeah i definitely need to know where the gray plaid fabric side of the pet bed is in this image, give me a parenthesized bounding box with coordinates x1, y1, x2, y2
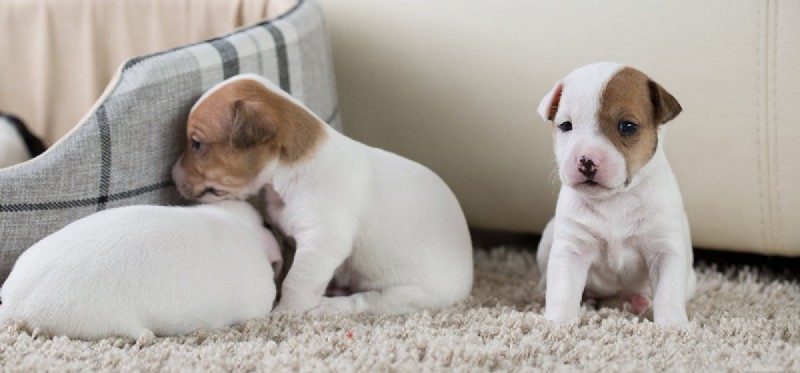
(0, 0, 341, 281)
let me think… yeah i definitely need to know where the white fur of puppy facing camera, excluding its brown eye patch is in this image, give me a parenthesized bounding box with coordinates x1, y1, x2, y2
(537, 63, 695, 325)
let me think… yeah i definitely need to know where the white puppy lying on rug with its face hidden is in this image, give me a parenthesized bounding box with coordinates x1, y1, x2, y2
(0, 201, 281, 339)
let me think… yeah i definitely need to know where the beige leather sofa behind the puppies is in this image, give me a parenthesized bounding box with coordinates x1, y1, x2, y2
(322, 0, 800, 256)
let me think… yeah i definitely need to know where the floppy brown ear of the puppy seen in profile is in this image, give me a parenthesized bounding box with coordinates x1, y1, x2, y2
(230, 100, 275, 149)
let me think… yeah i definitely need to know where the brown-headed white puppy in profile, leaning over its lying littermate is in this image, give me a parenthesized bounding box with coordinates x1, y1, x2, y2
(173, 74, 472, 314)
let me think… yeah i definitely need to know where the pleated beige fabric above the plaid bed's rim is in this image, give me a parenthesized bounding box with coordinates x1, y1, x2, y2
(0, 0, 297, 144)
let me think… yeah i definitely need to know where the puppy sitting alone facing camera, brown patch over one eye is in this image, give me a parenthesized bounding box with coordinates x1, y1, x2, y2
(537, 63, 695, 325)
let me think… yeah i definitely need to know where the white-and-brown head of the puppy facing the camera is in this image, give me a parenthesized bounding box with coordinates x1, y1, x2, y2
(539, 62, 682, 198)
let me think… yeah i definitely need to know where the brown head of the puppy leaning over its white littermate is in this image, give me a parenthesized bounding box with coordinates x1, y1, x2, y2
(172, 74, 325, 202)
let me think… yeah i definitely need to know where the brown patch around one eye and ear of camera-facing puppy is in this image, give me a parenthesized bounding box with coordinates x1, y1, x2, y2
(598, 67, 682, 181)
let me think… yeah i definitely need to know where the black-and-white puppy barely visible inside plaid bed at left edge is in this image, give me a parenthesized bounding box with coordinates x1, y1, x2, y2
(0, 112, 47, 168)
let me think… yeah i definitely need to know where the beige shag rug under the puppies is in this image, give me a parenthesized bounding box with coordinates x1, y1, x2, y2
(0, 248, 800, 372)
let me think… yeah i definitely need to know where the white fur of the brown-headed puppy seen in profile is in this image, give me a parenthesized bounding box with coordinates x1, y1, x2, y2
(174, 75, 473, 314)
